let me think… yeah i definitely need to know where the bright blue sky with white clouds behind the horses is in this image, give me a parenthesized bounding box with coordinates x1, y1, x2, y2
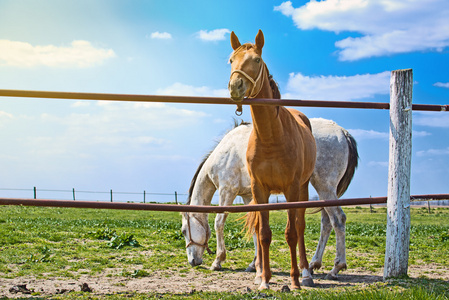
(0, 0, 449, 200)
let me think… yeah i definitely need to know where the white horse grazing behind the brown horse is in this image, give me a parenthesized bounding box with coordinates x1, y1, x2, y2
(182, 118, 358, 279)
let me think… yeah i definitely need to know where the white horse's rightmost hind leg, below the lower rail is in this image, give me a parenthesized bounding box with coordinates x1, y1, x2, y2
(325, 206, 346, 280)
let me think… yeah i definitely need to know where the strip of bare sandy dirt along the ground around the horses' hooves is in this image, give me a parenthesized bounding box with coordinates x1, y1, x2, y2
(0, 265, 449, 298)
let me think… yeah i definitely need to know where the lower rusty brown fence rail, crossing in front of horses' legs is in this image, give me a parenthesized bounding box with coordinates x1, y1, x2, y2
(0, 194, 449, 213)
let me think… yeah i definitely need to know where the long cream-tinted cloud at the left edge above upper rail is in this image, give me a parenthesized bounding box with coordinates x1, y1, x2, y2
(0, 40, 116, 68)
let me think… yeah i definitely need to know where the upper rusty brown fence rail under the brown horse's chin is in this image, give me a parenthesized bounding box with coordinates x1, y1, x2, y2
(0, 89, 449, 111)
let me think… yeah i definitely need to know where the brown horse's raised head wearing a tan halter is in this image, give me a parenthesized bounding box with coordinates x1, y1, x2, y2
(228, 30, 267, 102)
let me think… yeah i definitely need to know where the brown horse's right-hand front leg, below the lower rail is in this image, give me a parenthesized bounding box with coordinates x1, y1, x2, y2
(285, 209, 301, 289)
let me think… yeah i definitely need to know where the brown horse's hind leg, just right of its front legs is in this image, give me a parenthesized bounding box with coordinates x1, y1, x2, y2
(296, 182, 315, 286)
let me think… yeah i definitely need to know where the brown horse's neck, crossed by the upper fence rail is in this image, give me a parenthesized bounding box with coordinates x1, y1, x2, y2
(247, 77, 282, 143)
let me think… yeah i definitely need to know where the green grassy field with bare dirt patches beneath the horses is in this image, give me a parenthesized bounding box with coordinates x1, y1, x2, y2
(0, 206, 449, 299)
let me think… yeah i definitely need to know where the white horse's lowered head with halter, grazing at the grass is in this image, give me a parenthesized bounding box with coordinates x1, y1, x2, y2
(181, 213, 211, 267)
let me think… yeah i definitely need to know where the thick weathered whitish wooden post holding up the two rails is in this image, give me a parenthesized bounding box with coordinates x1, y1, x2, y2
(383, 69, 413, 279)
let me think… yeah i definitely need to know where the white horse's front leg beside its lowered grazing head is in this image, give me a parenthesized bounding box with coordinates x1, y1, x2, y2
(210, 189, 237, 271)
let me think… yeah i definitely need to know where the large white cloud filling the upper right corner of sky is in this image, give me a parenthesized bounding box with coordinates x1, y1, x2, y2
(274, 0, 449, 61)
